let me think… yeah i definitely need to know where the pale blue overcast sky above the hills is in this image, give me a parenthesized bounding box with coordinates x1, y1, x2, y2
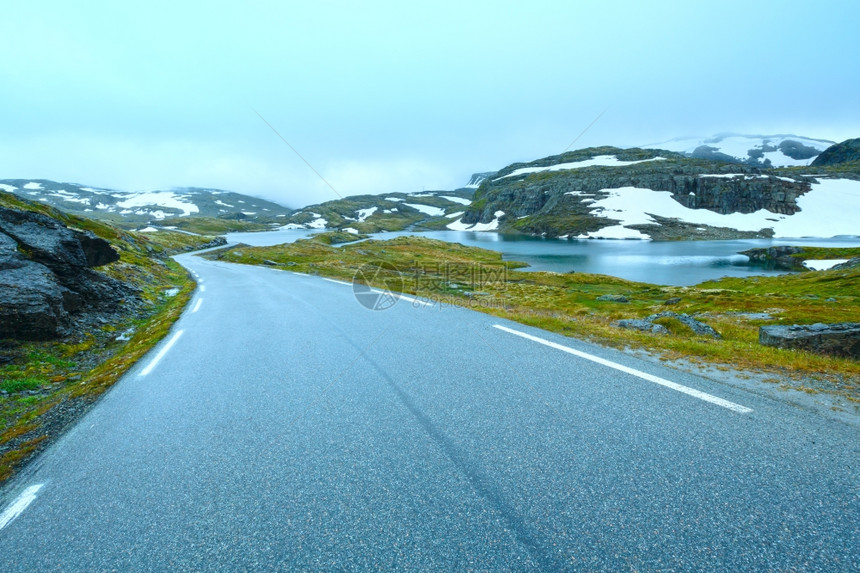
(0, 0, 860, 207)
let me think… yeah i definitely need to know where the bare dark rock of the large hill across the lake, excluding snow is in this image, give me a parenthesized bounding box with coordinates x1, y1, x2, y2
(461, 147, 811, 238)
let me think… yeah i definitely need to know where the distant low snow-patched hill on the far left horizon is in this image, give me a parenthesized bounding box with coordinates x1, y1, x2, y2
(0, 179, 292, 228)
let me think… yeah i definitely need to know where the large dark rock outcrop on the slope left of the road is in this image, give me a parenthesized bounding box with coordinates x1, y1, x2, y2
(0, 207, 134, 340)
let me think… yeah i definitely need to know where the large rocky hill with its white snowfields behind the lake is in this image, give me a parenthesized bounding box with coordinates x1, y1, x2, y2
(447, 147, 860, 240)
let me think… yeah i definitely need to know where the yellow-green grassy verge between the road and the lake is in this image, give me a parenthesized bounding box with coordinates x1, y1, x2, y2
(207, 237, 860, 406)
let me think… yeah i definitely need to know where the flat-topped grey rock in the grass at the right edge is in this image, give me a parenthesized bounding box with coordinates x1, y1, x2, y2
(758, 322, 860, 359)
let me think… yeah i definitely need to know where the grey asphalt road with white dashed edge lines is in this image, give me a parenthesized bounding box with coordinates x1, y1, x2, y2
(0, 256, 860, 573)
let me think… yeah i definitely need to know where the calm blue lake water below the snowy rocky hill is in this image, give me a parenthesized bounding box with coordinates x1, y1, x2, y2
(227, 229, 860, 286)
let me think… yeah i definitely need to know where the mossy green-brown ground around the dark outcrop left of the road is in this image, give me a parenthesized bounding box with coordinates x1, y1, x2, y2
(0, 193, 198, 483)
